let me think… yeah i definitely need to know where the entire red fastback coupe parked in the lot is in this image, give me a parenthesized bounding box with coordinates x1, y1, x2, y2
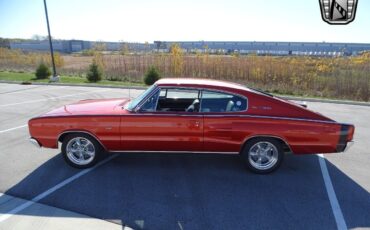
(28, 79, 354, 173)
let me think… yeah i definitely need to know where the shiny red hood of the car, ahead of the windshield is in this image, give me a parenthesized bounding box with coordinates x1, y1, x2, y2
(41, 99, 129, 117)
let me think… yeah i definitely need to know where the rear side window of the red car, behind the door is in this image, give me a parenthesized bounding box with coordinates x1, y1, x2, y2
(200, 90, 247, 112)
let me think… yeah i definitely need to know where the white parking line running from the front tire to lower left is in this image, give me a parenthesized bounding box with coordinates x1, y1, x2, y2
(0, 155, 117, 222)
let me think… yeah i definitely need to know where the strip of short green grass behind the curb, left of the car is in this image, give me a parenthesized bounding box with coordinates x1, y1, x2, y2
(0, 72, 144, 86)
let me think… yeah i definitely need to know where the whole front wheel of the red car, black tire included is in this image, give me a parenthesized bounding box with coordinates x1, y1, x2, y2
(62, 133, 103, 169)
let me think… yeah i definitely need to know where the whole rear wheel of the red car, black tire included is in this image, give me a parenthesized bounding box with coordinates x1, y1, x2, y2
(242, 138, 284, 174)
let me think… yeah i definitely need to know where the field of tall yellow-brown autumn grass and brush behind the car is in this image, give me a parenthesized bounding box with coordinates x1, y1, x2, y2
(0, 44, 370, 101)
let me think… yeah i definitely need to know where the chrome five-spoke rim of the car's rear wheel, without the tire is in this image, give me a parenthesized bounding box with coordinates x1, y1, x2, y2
(248, 141, 279, 170)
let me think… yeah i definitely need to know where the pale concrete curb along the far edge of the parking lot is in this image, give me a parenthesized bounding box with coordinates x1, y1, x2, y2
(0, 80, 370, 106)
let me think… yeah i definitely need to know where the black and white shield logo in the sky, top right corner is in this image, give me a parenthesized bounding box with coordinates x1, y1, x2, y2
(319, 0, 358, 25)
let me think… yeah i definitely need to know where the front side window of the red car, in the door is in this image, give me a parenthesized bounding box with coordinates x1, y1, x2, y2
(156, 88, 200, 112)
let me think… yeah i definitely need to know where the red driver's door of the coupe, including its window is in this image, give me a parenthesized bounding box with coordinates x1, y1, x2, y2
(121, 88, 203, 152)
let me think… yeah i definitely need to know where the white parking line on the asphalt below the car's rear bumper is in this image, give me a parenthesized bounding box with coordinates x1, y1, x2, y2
(318, 154, 348, 230)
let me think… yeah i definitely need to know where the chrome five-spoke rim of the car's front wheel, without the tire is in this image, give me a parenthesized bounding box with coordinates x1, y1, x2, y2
(66, 137, 96, 165)
